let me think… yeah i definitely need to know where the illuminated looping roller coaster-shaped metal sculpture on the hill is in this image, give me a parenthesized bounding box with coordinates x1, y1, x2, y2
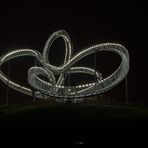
(0, 30, 129, 102)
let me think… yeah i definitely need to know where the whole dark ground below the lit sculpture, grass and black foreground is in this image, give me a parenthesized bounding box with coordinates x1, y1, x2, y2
(0, 101, 148, 147)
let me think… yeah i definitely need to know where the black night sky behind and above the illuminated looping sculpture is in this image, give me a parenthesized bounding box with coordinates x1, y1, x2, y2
(0, 0, 148, 104)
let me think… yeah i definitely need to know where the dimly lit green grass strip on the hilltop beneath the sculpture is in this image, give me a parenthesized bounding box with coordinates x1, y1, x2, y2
(0, 100, 148, 120)
